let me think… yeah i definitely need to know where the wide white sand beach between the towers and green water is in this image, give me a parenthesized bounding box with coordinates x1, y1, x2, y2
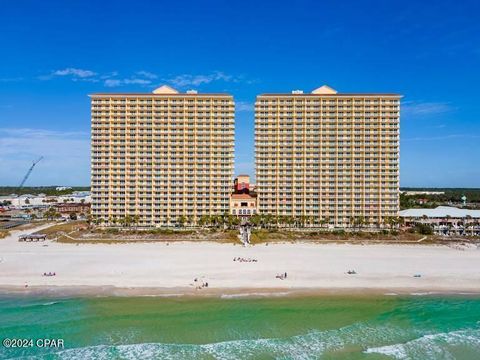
(0, 225, 480, 294)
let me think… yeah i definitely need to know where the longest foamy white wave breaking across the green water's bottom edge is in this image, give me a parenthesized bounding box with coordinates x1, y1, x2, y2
(4, 323, 412, 360)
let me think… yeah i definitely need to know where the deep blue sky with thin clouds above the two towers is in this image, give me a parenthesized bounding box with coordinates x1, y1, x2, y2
(0, 0, 480, 187)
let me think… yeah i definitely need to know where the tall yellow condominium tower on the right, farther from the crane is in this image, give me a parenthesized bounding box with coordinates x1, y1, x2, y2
(255, 86, 400, 227)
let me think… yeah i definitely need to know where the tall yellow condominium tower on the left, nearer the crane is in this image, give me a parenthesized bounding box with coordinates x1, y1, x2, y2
(91, 86, 234, 226)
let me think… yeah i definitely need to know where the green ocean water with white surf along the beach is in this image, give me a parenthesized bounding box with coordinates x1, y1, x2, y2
(0, 295, 480, 360)
